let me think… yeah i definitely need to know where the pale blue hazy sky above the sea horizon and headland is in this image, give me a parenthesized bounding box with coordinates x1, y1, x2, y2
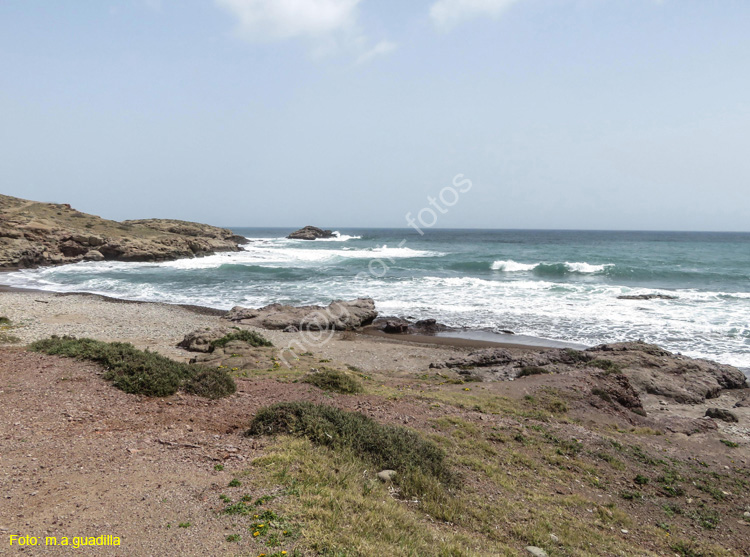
(0, 0, 750, 230)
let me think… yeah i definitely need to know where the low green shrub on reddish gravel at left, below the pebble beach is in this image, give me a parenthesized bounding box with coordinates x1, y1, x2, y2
(29, 336, 237, 398)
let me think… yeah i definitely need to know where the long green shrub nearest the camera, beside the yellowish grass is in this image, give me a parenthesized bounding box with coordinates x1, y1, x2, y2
(246, 401, 457, 494)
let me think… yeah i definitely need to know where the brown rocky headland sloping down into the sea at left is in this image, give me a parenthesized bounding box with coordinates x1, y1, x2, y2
(0, 195, 247, 269)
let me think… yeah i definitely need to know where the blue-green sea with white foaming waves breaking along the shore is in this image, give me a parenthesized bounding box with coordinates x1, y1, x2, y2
(2, 228, 750, 372)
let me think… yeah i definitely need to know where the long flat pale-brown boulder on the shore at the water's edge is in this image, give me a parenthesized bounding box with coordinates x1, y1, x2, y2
(224, 298, 378, 331)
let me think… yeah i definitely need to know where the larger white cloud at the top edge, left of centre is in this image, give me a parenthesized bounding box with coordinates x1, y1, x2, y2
(215, 0, 360, 41)
